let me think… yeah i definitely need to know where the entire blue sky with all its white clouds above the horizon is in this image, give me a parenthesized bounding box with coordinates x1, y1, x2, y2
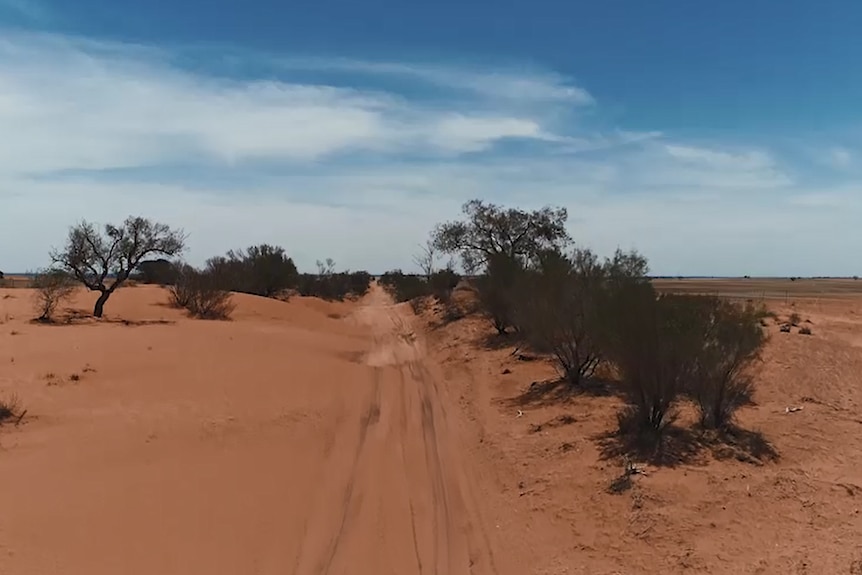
(0, 0, 862, 275)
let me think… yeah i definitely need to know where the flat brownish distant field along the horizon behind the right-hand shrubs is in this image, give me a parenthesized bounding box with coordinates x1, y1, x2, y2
(653, 278, 862, 299)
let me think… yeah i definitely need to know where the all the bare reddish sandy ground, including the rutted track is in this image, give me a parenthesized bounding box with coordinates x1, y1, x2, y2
(0, 286, 862, 575)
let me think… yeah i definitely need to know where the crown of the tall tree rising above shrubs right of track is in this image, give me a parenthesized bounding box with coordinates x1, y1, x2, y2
(432, 200, 571, 272)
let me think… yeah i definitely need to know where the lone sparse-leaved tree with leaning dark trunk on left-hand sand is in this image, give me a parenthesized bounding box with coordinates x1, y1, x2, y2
(51, 216, 186, 317)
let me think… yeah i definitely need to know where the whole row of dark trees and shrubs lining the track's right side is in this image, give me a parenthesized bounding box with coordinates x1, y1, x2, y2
(434, 202, 776, 462)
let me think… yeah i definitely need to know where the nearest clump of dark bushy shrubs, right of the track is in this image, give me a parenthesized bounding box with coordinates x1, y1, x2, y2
(613, 286, 766, 446)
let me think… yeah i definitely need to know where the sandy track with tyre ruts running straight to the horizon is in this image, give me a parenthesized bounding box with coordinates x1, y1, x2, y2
(296, 291, 497, 575)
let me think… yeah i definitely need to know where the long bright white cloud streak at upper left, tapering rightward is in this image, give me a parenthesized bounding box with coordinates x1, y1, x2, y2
(0, 32, 568, 172)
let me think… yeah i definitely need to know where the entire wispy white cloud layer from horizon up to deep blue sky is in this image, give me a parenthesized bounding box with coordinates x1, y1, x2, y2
(0, 29, 862, 274)
